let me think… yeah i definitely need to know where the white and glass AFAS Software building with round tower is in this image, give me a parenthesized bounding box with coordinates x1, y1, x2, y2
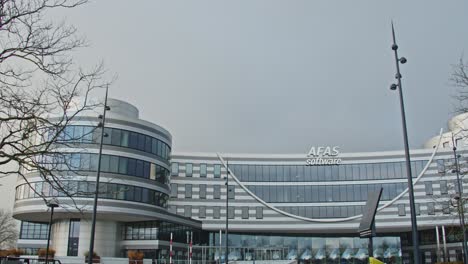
(10, 100, 468, 263)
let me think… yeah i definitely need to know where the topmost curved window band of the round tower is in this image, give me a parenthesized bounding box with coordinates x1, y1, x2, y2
(59, 126, 171, 160)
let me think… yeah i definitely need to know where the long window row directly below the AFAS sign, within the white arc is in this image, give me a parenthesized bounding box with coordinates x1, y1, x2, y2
(229, 161, 426, 182)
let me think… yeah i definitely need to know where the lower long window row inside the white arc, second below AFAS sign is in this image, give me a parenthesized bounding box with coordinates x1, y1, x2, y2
(247, 183, 406, 203)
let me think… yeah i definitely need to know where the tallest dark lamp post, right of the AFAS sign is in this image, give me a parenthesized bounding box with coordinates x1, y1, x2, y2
(390, 23, 421, 264)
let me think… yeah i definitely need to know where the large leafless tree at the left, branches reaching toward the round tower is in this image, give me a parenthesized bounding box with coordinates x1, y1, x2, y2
(0, 0, 108, 205)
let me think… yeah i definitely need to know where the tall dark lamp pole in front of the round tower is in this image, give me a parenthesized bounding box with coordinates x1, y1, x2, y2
(88, 87, 109, 263)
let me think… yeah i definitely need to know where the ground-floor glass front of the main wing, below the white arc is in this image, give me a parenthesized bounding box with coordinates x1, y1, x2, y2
(208, 232, 402, 264)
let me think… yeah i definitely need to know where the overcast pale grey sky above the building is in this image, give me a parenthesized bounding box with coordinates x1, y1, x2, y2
(57, 0, 468, 153)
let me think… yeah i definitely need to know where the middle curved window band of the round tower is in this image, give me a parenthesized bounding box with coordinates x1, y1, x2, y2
(40, 153, 169, 184)
